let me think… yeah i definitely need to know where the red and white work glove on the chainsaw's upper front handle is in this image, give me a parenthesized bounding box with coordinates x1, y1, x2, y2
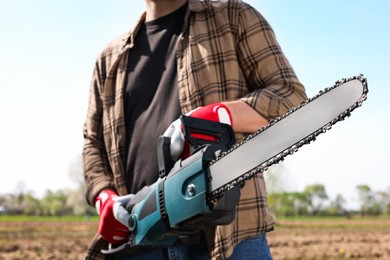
(164, 102, 233, 161)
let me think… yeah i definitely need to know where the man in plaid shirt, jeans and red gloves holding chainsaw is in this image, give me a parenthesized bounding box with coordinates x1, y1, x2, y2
(83, 0, 306, 259)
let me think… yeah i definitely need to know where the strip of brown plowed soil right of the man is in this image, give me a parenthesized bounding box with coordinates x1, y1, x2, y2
(268, 219, 390, 259)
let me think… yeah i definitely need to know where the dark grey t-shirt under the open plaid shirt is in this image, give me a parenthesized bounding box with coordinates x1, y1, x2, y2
(124, 5, 186, 193)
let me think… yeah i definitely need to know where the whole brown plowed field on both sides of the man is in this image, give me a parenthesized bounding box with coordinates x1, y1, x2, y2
(0, 218, 390, 260)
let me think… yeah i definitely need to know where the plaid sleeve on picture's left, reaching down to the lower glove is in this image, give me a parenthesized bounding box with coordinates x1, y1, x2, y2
(83, 60, 115, 206)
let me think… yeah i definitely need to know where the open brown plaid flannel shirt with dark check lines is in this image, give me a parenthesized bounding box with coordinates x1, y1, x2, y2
(83, 0, 306, 259)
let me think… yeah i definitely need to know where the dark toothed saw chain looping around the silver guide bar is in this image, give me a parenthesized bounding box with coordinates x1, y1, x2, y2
(209, 74, 368, 202)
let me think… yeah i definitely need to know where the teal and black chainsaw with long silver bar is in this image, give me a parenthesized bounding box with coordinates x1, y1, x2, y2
(102, 75, 368, 254)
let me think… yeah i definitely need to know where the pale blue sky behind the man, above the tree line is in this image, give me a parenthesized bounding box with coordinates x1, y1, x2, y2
(0, 0, 390, 207)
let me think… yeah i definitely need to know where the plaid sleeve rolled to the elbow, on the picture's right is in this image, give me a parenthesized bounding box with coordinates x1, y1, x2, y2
(237, 4, 307, 120)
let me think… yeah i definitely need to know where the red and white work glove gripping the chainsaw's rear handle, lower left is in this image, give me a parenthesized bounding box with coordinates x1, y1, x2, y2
(95, 190, 134, 244)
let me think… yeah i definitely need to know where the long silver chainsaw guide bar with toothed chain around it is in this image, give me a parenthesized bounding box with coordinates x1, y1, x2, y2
(208, 75, 368, 200)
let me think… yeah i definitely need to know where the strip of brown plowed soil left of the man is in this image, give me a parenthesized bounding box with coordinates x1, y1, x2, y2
(0, 221, 98, 260)
